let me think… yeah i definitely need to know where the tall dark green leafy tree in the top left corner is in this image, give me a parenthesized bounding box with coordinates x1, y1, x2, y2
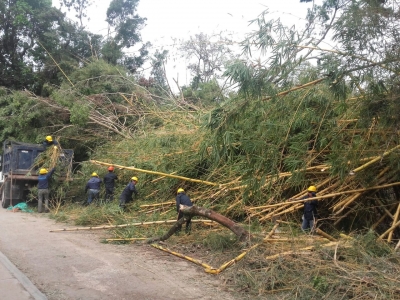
(0, 0, 63, 89)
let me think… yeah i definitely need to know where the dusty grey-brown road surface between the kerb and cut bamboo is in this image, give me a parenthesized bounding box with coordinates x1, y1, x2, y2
(0, 209, 238, 300)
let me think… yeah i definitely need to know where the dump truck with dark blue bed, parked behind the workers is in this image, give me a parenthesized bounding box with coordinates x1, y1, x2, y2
(0, 140, 74, 208)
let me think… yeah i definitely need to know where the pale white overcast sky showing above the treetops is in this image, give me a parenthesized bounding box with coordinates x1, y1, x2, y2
(53, 0, 312, 84)
